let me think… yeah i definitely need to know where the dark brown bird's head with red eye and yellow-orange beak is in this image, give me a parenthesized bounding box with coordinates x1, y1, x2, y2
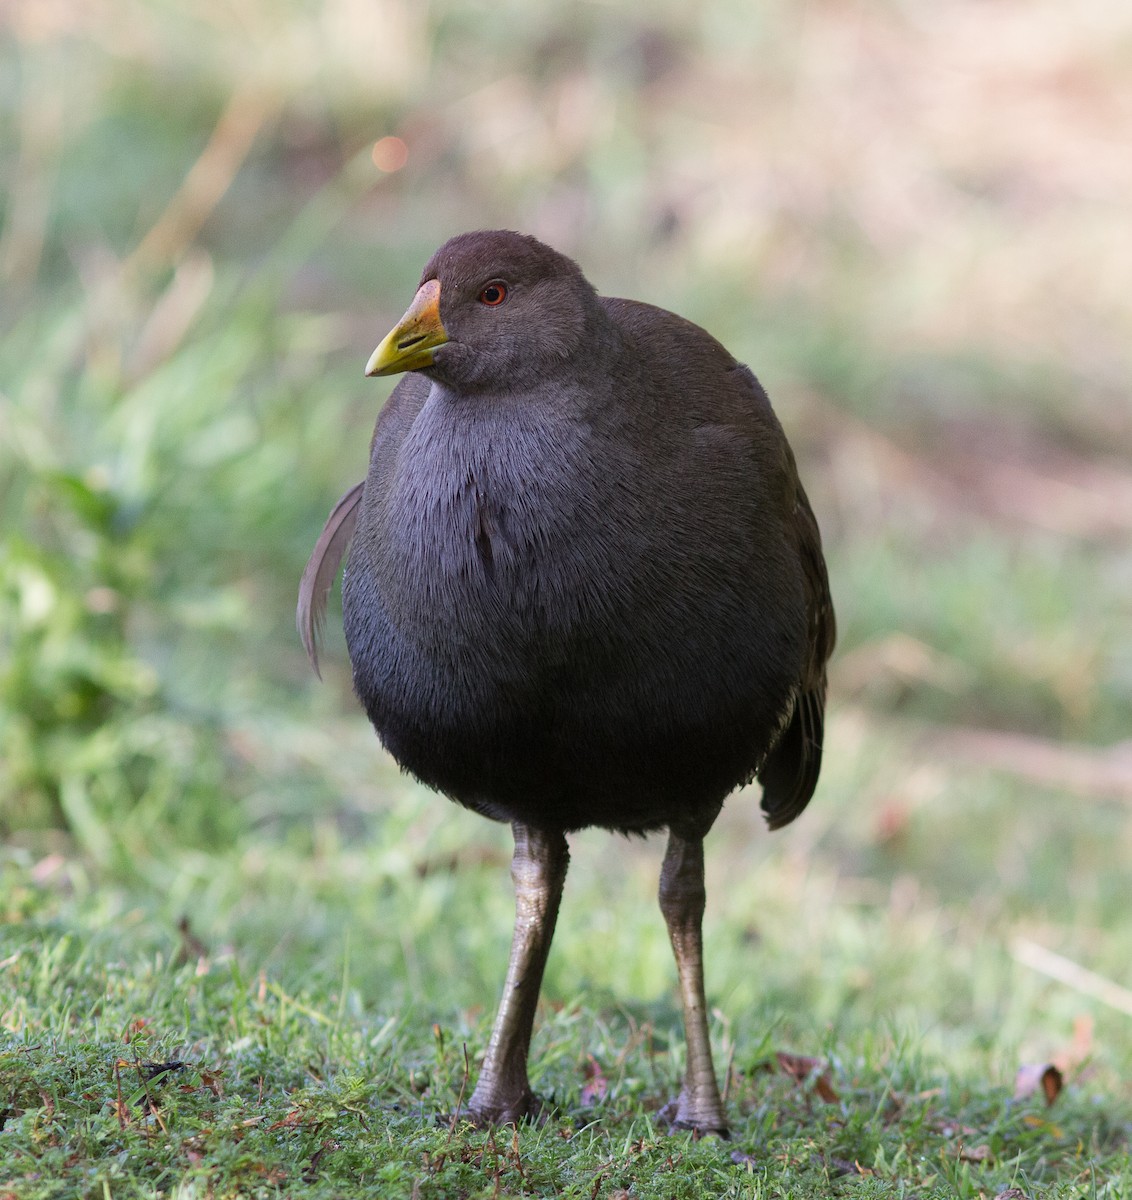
(366, 230, 603, 392)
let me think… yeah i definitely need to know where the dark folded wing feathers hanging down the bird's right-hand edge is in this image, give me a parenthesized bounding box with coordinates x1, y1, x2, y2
(759, 484, 837, 829)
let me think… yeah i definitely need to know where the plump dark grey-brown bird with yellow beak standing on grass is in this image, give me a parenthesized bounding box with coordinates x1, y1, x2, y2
(298, 230, 835, 1138)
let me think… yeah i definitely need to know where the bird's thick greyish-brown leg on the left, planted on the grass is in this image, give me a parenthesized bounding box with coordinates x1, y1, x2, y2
(468, 821, 570, 1126)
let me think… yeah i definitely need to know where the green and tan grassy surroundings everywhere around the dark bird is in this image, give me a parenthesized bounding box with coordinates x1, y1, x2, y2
(0, 0, 1132, 1200)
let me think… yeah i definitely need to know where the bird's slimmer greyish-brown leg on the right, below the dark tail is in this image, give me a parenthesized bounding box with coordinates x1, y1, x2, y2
(660, 832, 727, 1138)
